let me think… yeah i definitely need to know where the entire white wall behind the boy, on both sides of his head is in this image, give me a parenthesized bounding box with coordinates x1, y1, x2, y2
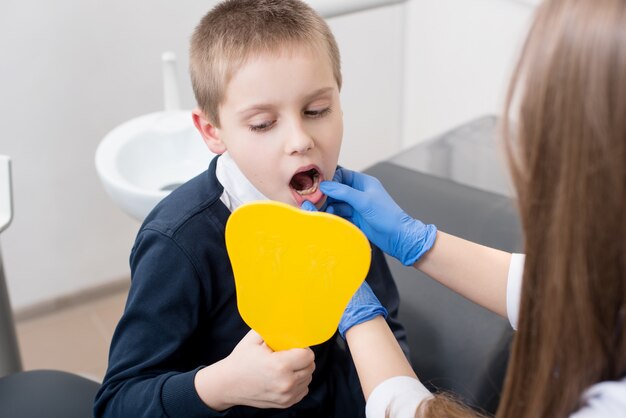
(0, 0, 529, 309)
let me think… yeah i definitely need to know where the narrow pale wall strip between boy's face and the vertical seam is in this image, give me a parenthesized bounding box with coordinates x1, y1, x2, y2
(329, 5, 404, 170)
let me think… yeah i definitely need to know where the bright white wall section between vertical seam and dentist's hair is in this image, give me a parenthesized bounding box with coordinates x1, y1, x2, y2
(402, 0, 539, 147)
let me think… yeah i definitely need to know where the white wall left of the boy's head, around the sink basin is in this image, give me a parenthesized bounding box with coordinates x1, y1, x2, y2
(0, 0, 208, 309)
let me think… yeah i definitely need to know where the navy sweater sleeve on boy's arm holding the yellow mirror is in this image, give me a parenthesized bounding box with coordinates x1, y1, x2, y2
(94, 230, 225, 417)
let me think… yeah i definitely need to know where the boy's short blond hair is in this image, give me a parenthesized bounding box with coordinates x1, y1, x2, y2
(189, 0, 342, 127)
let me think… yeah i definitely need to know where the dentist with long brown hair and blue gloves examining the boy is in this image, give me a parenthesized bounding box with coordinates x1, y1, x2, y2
(303, 0, 626, 418)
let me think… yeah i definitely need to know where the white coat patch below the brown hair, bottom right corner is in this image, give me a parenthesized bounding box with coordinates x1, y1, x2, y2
(570, 378, 626, 418)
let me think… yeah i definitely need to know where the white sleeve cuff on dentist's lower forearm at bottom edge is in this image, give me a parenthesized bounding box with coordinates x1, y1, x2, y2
(365, 376, 433, 418)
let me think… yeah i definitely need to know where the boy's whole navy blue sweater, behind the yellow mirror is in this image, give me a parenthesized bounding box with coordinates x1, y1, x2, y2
(94, 158, 408, 418)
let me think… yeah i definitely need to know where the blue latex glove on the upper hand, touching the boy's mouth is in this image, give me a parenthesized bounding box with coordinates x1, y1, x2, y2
(314, 168, 437, 266)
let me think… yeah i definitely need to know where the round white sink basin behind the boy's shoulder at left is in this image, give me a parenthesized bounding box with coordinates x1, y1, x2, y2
(96, 110, 215, 221)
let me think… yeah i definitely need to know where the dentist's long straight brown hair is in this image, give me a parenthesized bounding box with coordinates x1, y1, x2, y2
(423, 0, 626, 418)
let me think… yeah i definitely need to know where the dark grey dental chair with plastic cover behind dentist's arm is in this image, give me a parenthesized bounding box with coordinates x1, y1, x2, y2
(366, 117, 522, 413)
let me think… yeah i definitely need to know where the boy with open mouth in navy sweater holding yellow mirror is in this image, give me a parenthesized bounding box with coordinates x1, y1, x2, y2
(95, 0, 406, 418)
